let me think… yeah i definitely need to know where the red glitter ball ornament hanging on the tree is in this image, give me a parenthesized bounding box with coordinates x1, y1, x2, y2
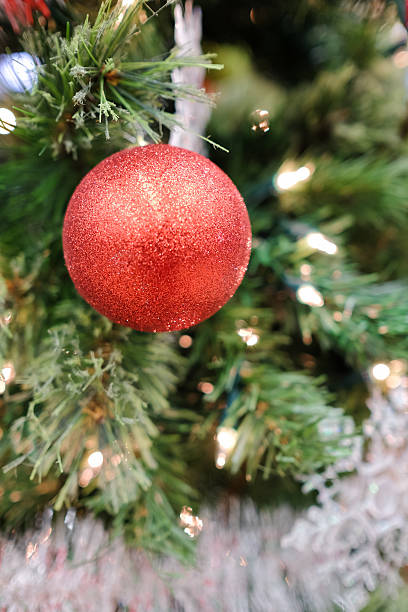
(63, 144, 251, 332)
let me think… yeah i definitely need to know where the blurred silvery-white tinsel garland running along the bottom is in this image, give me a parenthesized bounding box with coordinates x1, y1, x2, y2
(0, 500, 310, 612)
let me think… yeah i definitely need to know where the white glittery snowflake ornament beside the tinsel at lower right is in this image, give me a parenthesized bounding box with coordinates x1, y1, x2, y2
(282, 384, 408, 612)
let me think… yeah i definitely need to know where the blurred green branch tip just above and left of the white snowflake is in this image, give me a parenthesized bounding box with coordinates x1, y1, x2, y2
(217, 362, 348, 479)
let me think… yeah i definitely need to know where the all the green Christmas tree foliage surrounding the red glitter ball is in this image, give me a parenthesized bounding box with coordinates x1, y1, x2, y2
(0, 0, 408, 558)
